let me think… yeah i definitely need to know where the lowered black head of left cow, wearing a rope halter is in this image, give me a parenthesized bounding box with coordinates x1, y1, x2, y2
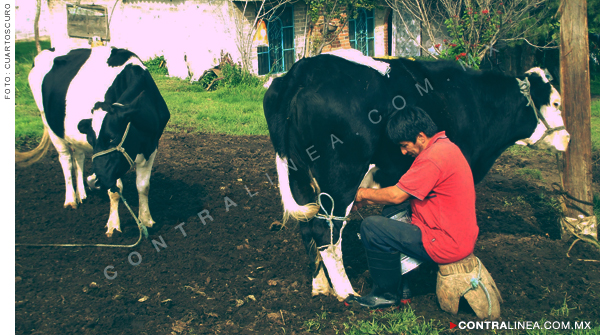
(78, 103, 141, 192)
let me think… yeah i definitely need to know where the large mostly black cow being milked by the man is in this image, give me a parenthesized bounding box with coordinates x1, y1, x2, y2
(263, 50, 569, 300)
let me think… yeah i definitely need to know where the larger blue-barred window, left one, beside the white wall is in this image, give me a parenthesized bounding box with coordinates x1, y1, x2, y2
(257, 6, 296, 75)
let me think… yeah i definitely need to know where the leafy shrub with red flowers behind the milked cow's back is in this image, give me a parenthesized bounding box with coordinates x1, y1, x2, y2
(386, 0, 550, 67)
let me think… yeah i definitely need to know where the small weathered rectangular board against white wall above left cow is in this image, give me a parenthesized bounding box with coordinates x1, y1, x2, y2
(67, 4, 110, 40)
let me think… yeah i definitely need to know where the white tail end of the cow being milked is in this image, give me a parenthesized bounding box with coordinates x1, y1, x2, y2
(275, 154, 319, 225)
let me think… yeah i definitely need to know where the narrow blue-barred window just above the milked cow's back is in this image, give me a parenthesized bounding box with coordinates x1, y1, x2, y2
(348, 8, 375, 57)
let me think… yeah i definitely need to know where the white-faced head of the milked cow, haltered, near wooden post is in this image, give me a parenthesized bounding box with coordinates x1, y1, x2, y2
(517, 67, 570, 151)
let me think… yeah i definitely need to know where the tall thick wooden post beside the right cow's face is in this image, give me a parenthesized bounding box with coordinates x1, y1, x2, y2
(560, 0, 594, 217)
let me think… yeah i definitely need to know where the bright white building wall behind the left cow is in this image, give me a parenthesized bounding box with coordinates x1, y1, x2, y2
(43, 0, 247, 78)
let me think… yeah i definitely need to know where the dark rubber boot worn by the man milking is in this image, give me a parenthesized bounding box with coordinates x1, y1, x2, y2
(353, 250, 402, 308)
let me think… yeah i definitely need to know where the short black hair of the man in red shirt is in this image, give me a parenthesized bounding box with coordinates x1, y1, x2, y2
(387, 106, 437, 143)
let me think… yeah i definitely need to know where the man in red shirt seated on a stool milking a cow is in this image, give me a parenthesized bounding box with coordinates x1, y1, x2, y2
(353, 107, 479, 308)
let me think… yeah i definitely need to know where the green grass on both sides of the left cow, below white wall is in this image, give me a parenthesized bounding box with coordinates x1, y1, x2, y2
(15, 42, 268, 139)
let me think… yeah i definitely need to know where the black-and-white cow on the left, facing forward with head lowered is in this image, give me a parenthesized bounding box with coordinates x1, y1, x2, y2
(16, 47, 170, 237)
